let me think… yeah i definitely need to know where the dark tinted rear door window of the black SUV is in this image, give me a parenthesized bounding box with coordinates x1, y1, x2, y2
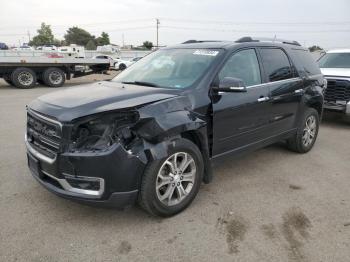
(260, 48, 293, 82)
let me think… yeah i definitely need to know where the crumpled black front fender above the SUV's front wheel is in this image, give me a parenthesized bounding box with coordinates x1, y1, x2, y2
(126, 97, 212, 182)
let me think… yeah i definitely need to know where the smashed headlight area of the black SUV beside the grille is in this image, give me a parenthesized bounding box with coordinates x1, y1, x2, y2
(70, 111, 138, 151)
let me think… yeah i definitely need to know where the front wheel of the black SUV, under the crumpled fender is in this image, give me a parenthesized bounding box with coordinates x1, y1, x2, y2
(139, 138, 204, 217)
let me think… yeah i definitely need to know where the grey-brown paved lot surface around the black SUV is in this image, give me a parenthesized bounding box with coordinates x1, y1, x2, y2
(0, 75, 350, 262)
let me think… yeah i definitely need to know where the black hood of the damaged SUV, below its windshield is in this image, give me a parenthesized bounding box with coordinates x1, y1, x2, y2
(29, 81, 179, 122)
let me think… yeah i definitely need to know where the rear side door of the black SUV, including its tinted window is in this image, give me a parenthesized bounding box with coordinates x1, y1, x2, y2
(258, 47, 304, 136)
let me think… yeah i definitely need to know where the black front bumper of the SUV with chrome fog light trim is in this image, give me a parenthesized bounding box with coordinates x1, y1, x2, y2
(25, 136, 145, 207)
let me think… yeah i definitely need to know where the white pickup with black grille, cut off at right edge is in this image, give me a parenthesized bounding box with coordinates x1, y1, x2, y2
(318, 49, 350, 115)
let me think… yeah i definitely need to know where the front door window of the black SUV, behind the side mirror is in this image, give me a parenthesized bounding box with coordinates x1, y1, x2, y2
(219, 49, 261, 86)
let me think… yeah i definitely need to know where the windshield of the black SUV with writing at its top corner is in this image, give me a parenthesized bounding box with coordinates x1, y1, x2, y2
(112, 49, 220, 89)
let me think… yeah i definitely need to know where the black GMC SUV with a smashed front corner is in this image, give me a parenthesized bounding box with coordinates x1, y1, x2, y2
(26, 37, 326, 216)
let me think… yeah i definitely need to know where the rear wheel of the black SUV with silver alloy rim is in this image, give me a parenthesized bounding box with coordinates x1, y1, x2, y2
(287, 108, 320, 154)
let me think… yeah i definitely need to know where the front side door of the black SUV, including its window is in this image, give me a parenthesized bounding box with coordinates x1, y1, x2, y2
(212, 48, 270, 157)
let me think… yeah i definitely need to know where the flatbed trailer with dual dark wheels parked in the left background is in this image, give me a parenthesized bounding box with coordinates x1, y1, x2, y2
(0, 53, 110, 89)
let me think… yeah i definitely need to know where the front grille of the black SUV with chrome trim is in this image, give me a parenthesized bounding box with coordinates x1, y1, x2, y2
(27, 111, 62, 159)
